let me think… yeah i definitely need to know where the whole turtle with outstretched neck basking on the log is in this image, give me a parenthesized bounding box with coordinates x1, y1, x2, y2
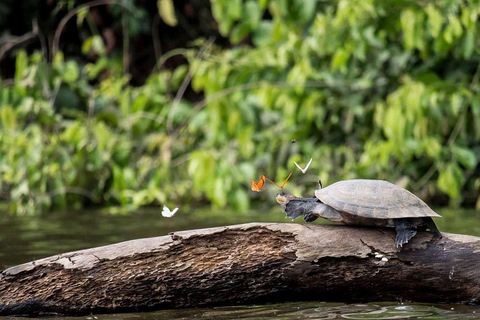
(276, 179, 442, 248)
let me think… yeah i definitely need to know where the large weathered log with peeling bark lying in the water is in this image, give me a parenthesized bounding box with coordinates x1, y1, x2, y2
(0, 223, 480, 315)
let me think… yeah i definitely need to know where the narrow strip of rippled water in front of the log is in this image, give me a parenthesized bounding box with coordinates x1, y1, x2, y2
(11, 302, 480, 320)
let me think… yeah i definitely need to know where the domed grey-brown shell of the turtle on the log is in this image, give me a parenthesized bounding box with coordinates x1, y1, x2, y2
(315, 179, 440, 219)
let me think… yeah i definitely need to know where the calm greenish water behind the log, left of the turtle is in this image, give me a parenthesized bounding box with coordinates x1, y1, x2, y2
(0, 204, 291, 270)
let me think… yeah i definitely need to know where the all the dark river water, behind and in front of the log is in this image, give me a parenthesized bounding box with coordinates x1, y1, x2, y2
(0, 208, 480, 320)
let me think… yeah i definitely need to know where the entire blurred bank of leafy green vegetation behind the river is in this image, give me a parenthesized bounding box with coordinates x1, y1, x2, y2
(0, 0, 480, 214)
